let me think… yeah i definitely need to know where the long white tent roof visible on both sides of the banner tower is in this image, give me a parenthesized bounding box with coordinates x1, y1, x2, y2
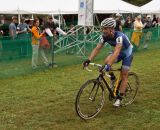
(0, 0, 140, 14)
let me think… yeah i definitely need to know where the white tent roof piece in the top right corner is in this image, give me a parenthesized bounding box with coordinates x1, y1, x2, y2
(140, 0, 160, 14)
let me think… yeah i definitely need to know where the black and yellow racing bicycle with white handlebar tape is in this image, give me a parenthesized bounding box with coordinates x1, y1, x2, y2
(75, 63, 139, 120)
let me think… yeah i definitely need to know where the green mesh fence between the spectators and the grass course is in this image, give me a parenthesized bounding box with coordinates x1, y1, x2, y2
(0, 27, 160, 78)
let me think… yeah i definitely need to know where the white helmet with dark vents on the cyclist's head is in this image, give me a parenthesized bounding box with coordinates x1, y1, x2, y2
(101, 18, 116, 28)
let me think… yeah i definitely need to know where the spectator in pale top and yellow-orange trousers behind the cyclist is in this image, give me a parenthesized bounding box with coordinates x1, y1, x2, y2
(131, 15, 144, 51)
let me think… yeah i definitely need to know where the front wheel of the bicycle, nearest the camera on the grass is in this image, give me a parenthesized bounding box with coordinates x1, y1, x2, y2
(75, 79, 104, 119)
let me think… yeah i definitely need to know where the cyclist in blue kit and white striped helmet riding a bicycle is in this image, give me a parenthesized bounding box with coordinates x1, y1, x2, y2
(83, 18, 133, 107)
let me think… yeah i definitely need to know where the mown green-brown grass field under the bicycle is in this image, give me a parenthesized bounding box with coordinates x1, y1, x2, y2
(0, 43, 160, 130)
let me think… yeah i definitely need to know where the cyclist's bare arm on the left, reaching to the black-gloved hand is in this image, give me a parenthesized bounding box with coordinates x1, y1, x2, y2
(89, 43, 104, 61)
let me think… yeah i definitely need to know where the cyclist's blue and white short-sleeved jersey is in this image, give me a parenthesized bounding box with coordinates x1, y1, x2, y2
(100, 31, 133, 58)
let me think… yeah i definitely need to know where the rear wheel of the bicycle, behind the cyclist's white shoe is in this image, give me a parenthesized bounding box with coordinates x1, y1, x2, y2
(122, 72, 139, 106)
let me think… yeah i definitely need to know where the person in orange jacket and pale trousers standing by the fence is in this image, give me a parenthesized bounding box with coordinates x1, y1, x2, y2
(31, 19, 50, 69)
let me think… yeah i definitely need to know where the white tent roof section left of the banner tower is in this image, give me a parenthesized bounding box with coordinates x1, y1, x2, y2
(0, 0, 78, 14)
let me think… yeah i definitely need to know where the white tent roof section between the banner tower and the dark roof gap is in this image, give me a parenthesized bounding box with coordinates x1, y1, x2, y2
(94, 0, 140, 13)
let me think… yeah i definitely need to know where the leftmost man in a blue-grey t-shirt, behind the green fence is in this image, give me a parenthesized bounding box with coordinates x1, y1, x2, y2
(9, 16, 17, 40)
